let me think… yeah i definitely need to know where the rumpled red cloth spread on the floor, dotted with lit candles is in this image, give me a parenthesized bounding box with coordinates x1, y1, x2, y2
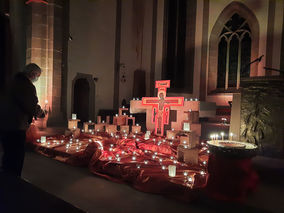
(29, 133, 209, 201)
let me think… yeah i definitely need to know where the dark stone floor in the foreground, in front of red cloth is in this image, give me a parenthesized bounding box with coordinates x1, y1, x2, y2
(11, 152, 284, 213)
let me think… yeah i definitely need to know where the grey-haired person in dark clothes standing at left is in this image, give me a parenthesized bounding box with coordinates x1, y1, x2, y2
(0, 63, 45, 177)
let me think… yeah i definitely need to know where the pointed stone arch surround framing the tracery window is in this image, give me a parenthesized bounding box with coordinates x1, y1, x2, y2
(207, 1, 259, 94)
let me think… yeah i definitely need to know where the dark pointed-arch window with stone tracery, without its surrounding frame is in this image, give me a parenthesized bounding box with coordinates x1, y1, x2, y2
(217, 13, 251, 90)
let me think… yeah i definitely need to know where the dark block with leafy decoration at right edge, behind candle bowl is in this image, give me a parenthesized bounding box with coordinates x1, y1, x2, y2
(240, 76, 284, 157)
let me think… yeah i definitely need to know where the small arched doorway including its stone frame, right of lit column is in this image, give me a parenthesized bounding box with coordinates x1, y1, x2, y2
(71, 73, 95, 121)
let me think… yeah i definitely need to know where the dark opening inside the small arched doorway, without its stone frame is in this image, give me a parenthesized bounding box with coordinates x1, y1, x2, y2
(73, 78, 90, 122)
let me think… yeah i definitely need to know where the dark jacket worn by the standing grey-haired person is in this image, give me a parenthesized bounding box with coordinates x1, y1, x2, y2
(0, 73, 44, 130)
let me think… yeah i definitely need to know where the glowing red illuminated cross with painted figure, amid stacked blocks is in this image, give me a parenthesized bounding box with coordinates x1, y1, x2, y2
(142, 80, 184, 136)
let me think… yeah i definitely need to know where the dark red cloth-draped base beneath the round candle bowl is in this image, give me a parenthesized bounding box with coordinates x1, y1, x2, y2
(207, 154, 258, 201)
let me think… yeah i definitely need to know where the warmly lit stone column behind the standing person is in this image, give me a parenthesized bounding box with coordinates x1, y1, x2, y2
(26, 0, 63, 125)
